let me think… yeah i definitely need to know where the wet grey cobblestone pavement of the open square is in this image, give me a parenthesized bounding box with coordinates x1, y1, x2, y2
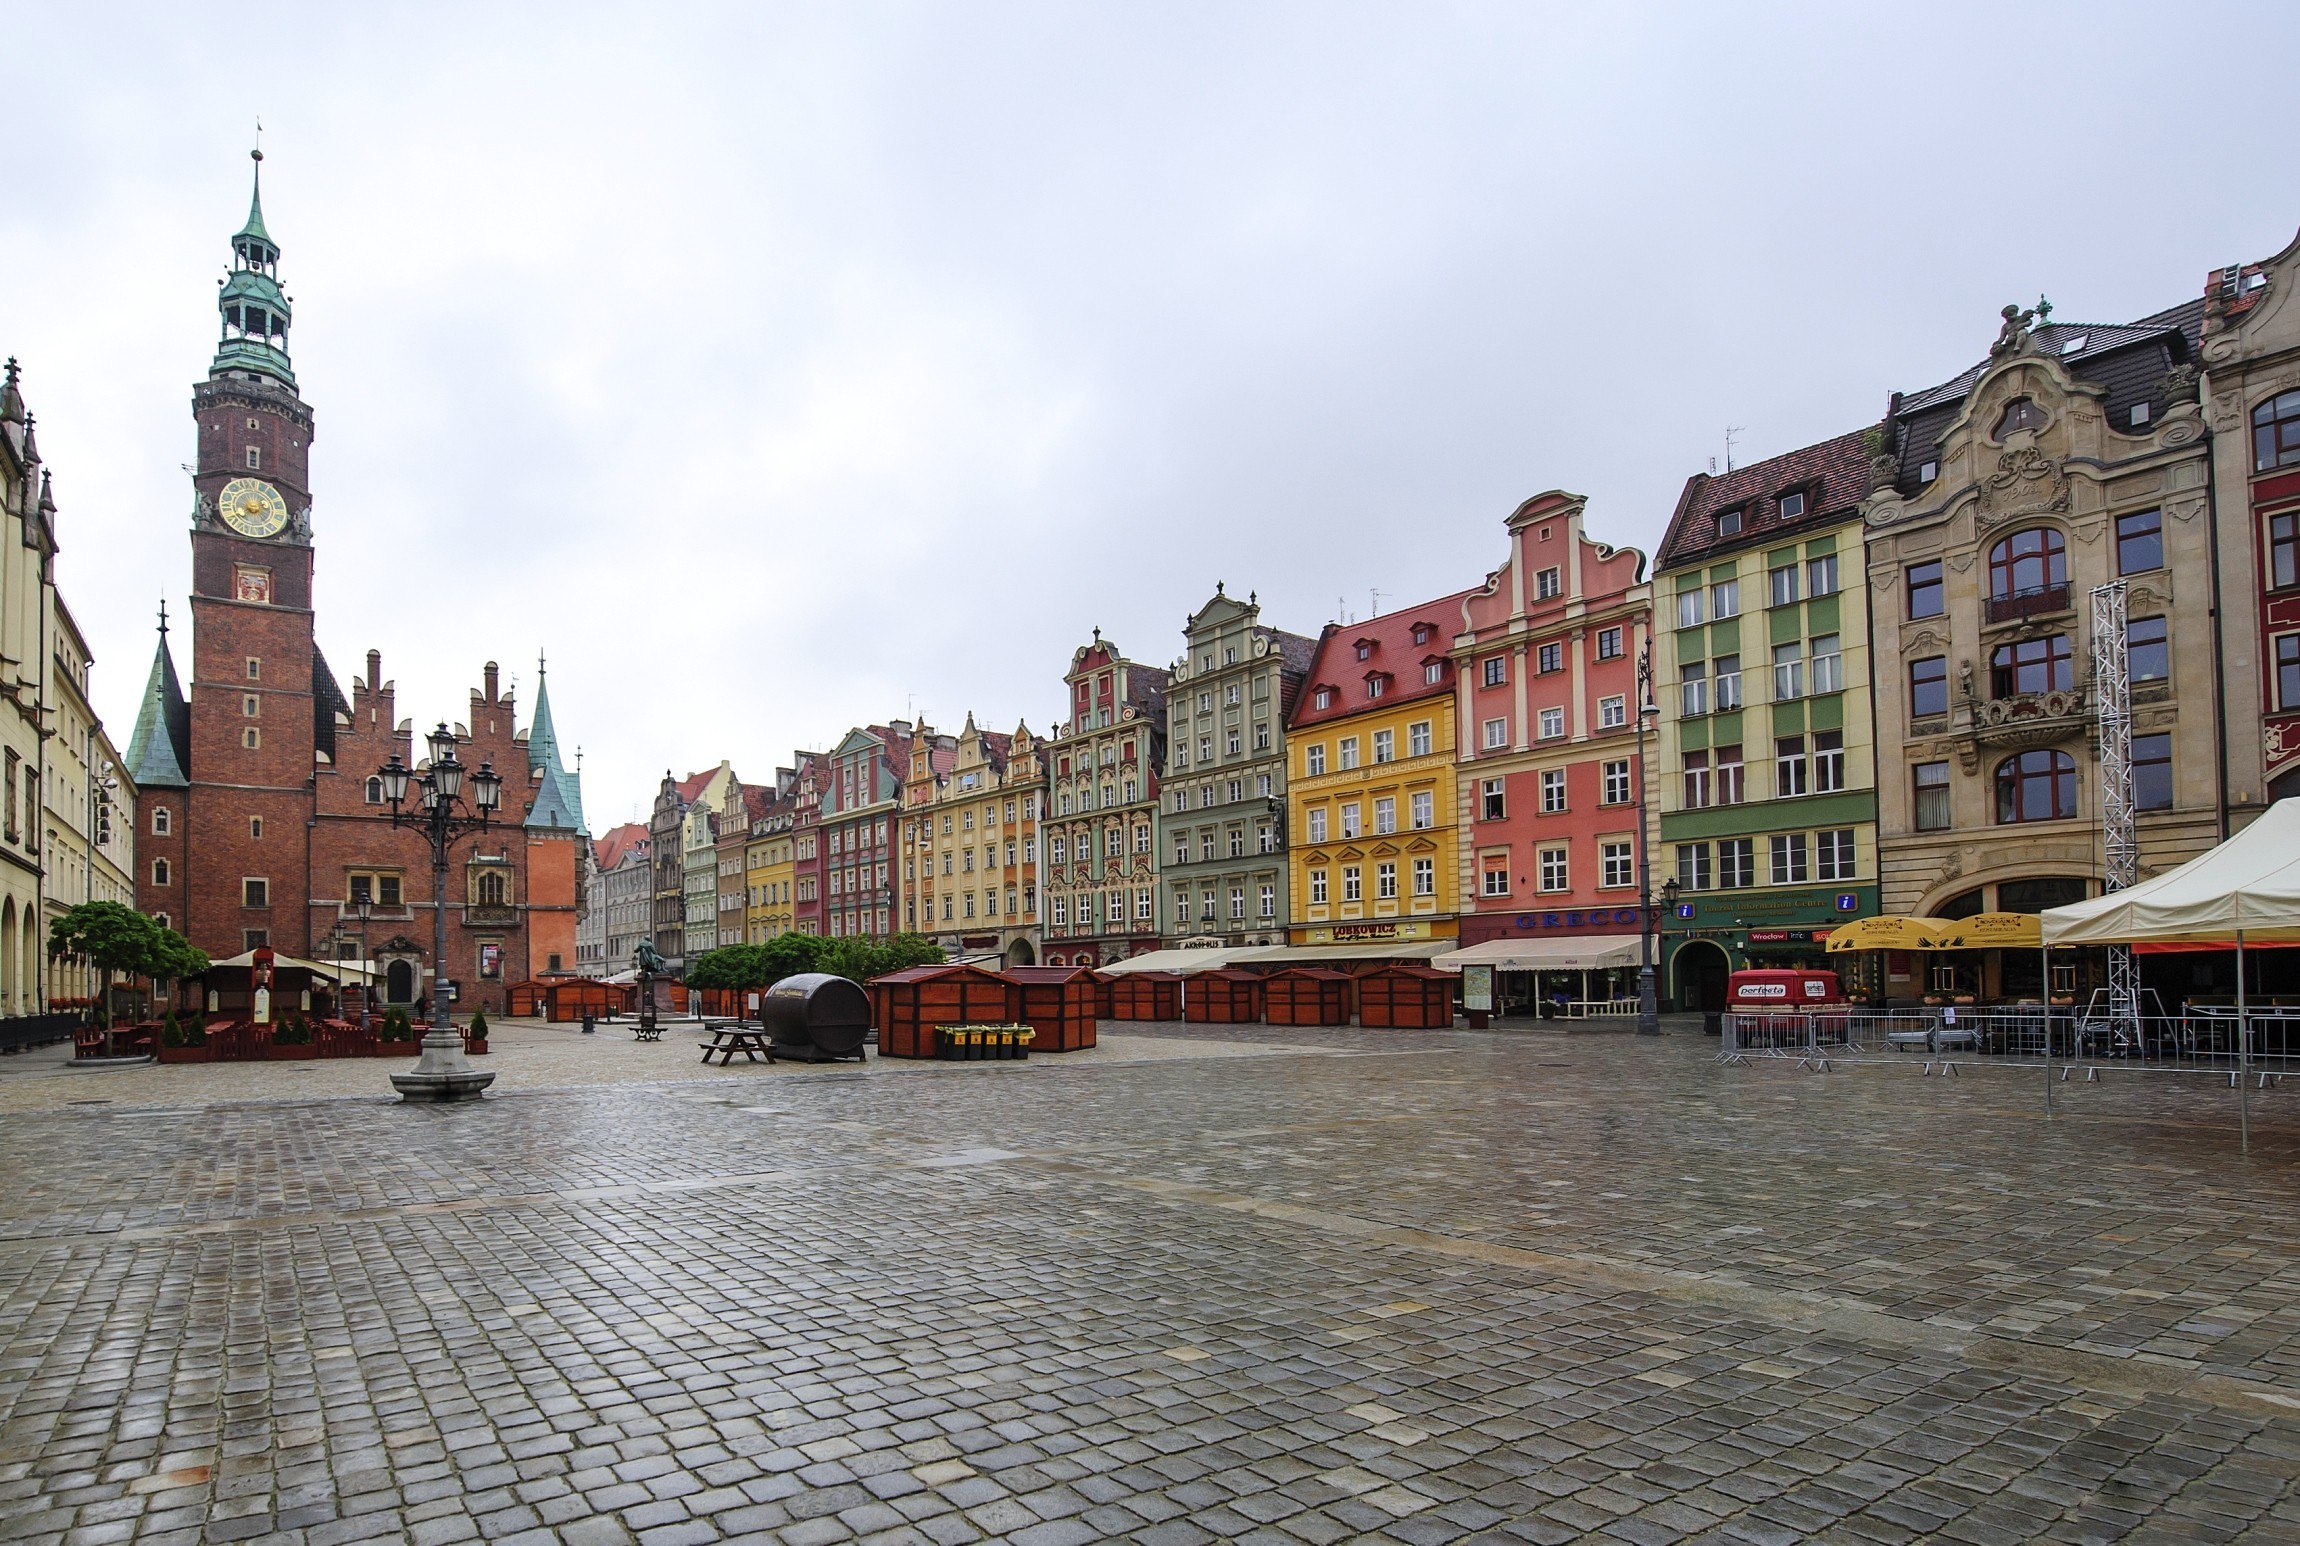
(0, 1026, 2300, 1546)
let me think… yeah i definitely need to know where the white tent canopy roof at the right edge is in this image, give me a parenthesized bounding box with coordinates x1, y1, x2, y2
(2045, 798, 2300, 946)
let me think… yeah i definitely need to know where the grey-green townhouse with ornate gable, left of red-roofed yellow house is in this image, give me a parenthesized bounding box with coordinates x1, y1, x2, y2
(1155, 584, 1318, 946)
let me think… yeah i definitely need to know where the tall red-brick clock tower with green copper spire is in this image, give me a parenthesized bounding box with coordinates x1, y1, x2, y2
(182, 152, 336, 957)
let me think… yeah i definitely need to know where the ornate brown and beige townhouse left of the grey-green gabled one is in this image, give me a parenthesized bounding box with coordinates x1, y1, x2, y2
(1042, 628, 1166, 966)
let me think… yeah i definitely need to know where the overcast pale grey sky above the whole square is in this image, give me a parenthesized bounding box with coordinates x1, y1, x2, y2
(0, 2, 2300, 831)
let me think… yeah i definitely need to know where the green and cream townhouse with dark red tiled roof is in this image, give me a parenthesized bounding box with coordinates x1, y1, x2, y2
(1651, 441, 1879, 1010)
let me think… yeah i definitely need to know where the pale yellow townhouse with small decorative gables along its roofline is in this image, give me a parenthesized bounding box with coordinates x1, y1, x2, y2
(902, 715, 1049, 966)
